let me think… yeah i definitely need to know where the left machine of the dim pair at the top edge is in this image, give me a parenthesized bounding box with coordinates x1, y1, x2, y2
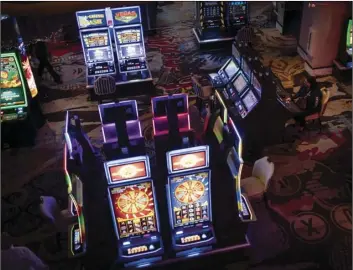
(193, 1, 234, 45)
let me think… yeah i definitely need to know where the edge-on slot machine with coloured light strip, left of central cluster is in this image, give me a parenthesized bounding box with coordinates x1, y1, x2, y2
(63, 111, 86, 257)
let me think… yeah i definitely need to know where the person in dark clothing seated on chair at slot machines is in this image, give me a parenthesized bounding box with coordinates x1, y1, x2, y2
(285, 77, 322, 130)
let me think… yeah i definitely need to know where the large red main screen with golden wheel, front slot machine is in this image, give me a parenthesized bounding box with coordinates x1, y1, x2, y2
(109, 181, 158, 238)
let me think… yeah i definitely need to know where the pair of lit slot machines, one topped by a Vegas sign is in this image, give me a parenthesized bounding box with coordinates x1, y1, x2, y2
(76, 6, 152, 93)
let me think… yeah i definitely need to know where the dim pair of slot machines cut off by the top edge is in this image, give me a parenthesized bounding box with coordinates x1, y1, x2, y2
(193, 1, 249, 44)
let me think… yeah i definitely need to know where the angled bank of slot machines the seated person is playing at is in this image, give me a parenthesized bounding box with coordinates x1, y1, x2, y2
(205, 42, 300, 160)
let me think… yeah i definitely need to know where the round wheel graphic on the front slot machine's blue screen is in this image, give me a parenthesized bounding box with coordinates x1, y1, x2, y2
(174, 180, 205, 204)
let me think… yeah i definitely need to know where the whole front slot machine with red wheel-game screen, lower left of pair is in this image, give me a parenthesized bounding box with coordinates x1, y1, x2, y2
(104, 156, 164, 267)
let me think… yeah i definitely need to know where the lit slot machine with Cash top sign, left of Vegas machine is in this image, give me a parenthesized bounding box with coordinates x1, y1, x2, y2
(76, 9, 116, 87)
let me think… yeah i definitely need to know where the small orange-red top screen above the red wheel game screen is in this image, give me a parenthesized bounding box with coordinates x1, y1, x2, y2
(109, 161, 147, 183)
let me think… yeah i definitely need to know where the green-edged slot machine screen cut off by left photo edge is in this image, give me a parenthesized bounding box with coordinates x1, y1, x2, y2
(0, 55, 27, 109)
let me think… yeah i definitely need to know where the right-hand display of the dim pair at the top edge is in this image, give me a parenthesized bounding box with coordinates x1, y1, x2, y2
(226, 1, 248, 30)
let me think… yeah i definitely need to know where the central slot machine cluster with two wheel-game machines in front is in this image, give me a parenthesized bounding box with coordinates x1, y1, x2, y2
(64, 94, 256, 267)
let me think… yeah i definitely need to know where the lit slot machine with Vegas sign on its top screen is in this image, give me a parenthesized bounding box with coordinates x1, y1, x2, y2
(111, 6, 152, 84)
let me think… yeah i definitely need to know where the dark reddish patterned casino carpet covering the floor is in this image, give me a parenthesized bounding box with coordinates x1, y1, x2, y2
(1, 2, 352, 270)
